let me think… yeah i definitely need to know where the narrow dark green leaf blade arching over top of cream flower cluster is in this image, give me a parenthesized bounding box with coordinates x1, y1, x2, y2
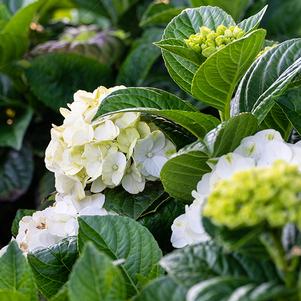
(94, 88, 195, 118)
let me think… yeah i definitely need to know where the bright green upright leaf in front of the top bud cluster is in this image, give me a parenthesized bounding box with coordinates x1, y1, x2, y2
(191, 29, 266, 114)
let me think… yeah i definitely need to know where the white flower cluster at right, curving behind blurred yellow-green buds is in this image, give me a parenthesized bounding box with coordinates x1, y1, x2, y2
(171, 129, 301, 248)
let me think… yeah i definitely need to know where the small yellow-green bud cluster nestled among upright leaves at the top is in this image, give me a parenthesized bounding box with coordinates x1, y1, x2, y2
(185, 25, 245, 57)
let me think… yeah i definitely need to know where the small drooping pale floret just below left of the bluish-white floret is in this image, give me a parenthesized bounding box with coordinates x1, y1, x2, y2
(121, 163, 145, 194)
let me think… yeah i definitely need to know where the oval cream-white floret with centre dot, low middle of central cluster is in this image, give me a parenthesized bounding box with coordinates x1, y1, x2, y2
(102, 152, 126, 186)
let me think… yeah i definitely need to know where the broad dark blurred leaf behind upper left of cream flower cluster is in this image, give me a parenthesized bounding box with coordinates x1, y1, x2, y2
(26, 53, 112, 110)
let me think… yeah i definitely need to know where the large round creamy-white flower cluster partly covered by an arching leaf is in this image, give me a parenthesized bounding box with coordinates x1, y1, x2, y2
(45, 86, 176, 200)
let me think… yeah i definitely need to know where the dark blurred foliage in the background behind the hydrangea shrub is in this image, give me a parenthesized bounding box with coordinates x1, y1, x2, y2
(0, 0, 301, 247)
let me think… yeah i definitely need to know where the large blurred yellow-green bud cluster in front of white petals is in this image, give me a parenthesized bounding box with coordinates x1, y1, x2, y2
(203, 161, 301, 229)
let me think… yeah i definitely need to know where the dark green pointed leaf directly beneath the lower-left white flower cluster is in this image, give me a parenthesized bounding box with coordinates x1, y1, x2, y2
(27, 237, 78, 298)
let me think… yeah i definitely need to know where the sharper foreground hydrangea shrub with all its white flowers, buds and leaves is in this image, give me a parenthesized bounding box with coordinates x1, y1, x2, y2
(0, 3, 301, 301)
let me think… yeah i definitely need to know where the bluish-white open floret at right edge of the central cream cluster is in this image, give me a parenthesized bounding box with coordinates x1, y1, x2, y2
(133, 130, 175, 178)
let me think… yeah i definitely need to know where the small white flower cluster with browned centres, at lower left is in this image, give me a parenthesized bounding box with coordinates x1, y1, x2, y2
(16, 193, 109, 254)
